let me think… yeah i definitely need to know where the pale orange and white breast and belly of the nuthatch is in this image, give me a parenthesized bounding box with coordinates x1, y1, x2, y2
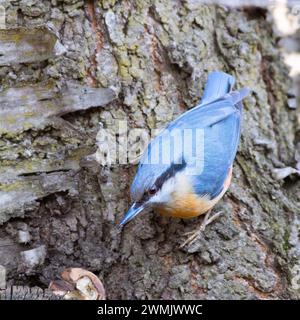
(157, 167, 232, 218)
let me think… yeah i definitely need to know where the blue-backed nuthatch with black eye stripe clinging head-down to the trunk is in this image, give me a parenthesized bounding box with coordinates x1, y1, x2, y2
(119, 71, 250, 245)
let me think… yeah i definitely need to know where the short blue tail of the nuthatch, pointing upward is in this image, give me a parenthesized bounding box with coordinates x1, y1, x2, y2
(201, 71, 235, 104)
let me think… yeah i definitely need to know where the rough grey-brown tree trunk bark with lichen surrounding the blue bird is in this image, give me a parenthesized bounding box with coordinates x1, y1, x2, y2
(0, 0, 300, 299)
